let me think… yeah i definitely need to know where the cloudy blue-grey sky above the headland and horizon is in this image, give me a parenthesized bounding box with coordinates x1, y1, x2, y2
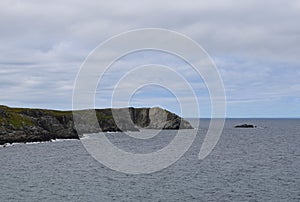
(0, 0, 300, 118)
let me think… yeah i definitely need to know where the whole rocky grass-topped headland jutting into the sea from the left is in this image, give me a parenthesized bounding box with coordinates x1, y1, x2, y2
(0, 105, 192, 145)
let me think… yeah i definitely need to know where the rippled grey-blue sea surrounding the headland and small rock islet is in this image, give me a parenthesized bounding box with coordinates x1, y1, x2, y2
(0, 119, 300, 202)
